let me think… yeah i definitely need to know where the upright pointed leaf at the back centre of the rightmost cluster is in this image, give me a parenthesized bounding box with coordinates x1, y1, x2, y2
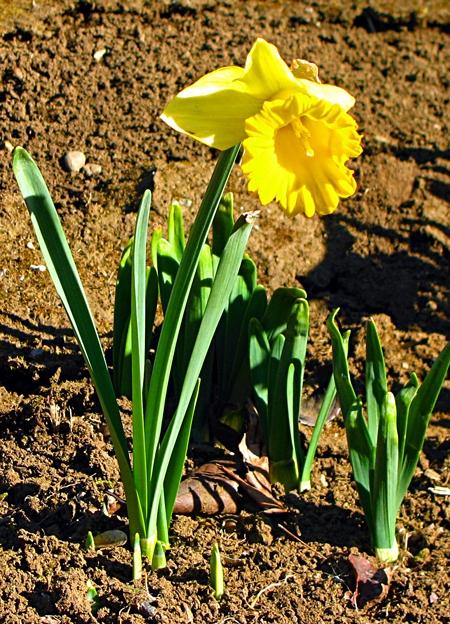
(366, 319, 387, 445)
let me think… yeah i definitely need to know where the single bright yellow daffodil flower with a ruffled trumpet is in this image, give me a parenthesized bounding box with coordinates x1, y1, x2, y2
(161, 39, 362, 217)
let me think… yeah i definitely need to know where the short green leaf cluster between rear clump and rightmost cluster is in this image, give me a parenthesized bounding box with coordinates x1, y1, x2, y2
(249, 288, 336, 491)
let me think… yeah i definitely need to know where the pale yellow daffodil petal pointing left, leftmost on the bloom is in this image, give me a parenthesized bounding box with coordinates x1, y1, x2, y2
(161, 67, 263, 150)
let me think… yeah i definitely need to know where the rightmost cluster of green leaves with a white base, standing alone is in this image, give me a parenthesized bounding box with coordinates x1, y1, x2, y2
(327, 311, 450, 561)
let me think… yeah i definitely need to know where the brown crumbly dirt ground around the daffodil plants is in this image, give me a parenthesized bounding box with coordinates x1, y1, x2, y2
(0, 0, 450, 624)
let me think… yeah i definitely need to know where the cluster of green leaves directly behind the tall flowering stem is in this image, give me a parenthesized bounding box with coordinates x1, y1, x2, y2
(148, 193, 267, 443)
